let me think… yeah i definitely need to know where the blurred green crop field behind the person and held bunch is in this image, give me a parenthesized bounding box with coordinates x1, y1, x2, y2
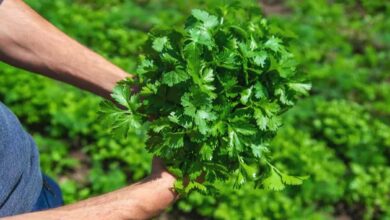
(0, 0, 390, 220)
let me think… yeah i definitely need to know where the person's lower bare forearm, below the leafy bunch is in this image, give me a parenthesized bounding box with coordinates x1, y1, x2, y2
(6, 173, 176, 220)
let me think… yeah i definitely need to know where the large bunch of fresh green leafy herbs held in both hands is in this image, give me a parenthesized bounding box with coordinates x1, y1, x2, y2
(102, 4, 310, 193)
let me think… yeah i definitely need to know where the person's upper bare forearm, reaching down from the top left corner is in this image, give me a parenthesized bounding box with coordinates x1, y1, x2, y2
(0, 0, 130, 97)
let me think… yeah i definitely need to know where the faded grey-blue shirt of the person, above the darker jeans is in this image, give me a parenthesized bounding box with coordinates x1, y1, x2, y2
(0, 102, 42, 217)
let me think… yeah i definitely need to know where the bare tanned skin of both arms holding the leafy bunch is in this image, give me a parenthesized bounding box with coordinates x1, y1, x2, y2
(0, 0, 177, 220)
